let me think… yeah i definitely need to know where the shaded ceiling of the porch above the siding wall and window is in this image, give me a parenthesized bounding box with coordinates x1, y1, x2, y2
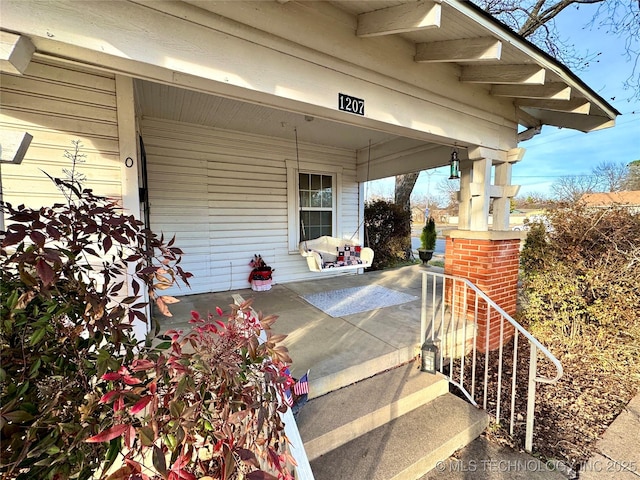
(135, 80, 452, 181)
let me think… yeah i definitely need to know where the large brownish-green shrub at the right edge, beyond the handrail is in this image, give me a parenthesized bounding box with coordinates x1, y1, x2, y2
(521, 205, 640, 367)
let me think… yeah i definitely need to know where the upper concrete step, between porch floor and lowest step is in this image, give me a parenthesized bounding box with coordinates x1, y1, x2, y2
(297, 360, 449, 460)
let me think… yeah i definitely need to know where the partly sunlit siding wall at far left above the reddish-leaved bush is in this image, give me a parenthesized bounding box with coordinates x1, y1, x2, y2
(0, 61, 121, 207)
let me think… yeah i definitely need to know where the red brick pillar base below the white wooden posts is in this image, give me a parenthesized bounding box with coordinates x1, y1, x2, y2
(444, 230, 520, 351)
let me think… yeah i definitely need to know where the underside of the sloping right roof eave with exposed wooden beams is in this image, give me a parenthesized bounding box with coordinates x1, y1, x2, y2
(328, 0, 619, 131)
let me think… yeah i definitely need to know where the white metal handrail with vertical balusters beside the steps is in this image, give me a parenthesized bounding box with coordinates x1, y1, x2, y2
(420, 272, 563, 452)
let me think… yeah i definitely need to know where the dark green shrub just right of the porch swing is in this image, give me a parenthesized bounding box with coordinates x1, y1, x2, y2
(364, 200, 411, 270)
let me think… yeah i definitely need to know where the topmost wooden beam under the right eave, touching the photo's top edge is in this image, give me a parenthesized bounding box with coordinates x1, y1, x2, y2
(356, 1, 442, 37)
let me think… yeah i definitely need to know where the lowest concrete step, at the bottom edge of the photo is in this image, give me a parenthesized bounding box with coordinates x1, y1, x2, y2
(311, 394, 489, 480)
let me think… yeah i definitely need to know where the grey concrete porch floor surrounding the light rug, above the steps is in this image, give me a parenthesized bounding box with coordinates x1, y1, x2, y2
(160, 265, 442, 398)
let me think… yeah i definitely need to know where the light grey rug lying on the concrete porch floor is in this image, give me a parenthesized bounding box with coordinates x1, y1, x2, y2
(302, 285, 418, 317)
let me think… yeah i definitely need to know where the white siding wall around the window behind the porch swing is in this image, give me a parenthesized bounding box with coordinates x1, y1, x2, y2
(142, 118, 359, 295)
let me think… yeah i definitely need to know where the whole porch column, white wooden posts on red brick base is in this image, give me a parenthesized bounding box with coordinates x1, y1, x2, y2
(444, 147, 522, 351)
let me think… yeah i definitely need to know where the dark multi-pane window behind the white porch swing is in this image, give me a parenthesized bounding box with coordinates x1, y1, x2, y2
(298, 173, 334, 240)
